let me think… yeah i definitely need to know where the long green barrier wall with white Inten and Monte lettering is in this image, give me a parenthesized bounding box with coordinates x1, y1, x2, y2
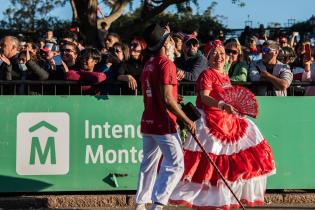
(0, 96, 315, 192)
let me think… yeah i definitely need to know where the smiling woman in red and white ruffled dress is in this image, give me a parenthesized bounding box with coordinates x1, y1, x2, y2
(171, 41, 276, 209)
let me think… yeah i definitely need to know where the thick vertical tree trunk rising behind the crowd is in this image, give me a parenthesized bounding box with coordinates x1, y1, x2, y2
(74, 0, 98, 47)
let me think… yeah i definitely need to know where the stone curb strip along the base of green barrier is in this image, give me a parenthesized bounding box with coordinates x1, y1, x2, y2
(0, 194, 315, 210)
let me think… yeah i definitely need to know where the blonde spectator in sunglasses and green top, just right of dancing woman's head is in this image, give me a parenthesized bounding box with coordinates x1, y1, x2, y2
(224, 39, 248, 82)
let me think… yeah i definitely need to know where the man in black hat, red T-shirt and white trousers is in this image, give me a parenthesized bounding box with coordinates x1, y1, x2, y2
(136, 24, 196, 210)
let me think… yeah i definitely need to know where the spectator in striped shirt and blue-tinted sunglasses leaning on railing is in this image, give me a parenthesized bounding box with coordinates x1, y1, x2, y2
(249, 40, 293, 96)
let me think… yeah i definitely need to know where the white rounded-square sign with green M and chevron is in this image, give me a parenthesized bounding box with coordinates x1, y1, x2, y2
(16, 112, 70, 175)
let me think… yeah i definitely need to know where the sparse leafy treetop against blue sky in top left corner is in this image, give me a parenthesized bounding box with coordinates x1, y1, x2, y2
(1, 0, 66, 32)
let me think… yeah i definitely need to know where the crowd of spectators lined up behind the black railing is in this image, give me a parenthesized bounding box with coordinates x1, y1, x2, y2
(0, 23, 315, 96)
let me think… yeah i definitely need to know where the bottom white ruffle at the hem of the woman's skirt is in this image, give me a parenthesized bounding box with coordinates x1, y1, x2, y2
(170, 171, 275, 207)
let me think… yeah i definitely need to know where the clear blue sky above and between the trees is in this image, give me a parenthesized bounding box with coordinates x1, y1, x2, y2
(0, 0, 315, 29)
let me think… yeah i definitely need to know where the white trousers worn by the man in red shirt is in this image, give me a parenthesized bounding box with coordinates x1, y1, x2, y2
(136, 133, 184, 205)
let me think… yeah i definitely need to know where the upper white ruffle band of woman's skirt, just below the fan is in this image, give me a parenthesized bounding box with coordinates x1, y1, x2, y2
(184, 109, 264, 155)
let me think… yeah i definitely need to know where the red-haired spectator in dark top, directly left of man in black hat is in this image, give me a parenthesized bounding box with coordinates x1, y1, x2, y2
(117, 37, 147, 95)
